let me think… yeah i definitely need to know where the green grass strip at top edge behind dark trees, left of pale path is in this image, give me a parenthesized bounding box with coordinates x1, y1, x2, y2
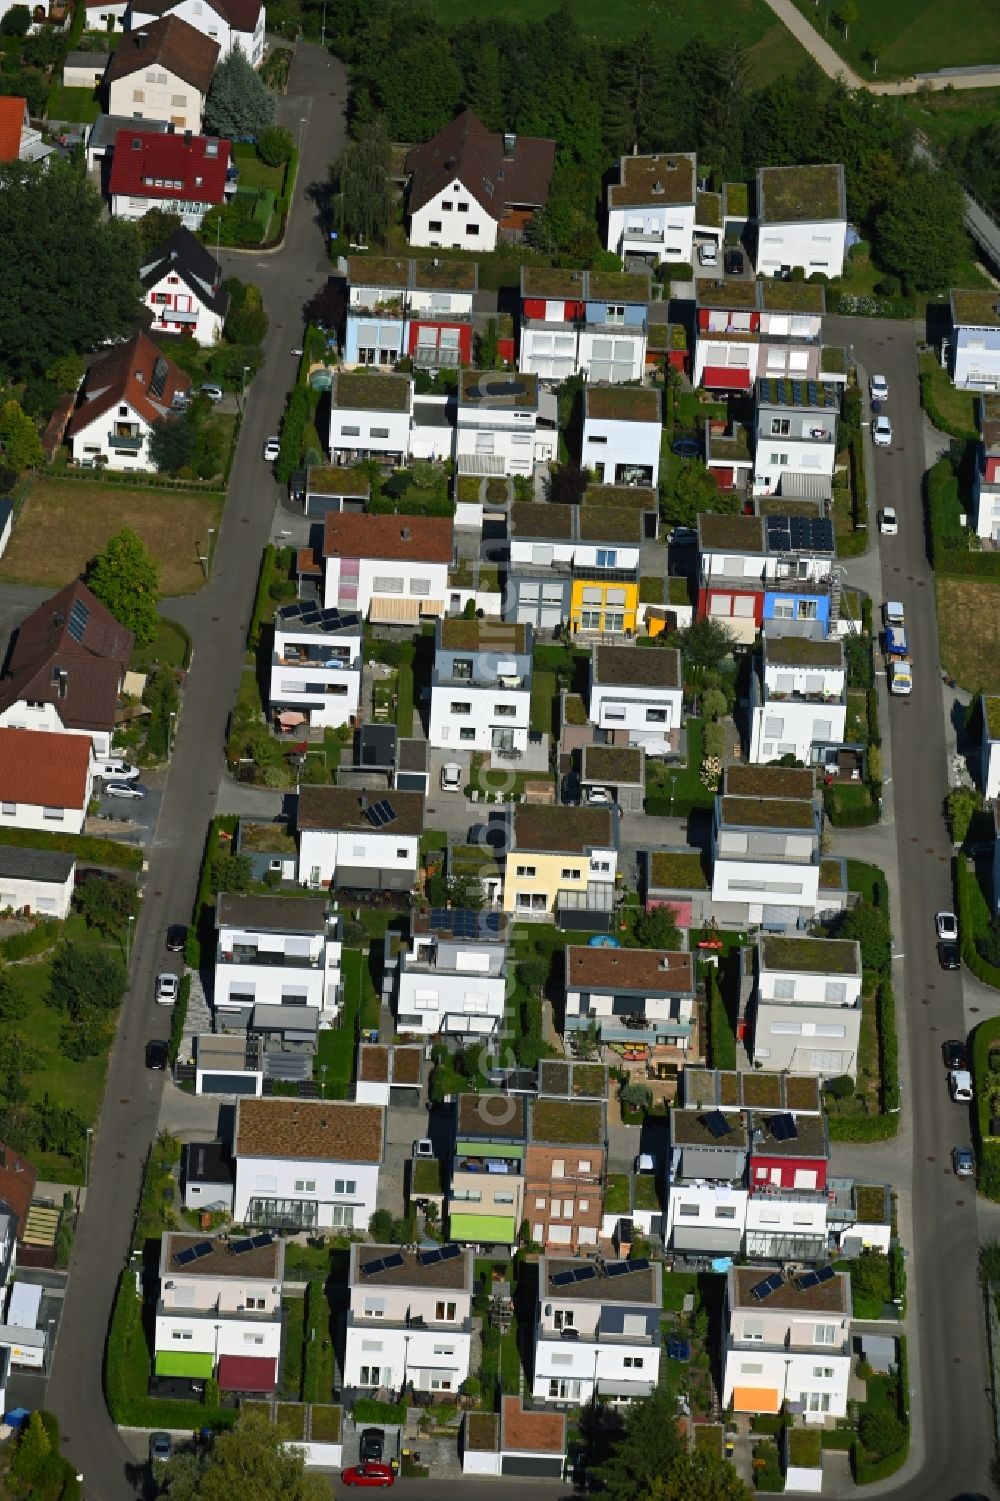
(434, 0, 806, 86)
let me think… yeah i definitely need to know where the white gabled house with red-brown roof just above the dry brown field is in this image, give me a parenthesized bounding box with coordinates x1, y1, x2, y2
(66, 333, 191, 470)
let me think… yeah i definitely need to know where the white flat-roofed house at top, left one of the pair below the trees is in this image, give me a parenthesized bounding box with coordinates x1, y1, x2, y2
(607, 152, 698, 266)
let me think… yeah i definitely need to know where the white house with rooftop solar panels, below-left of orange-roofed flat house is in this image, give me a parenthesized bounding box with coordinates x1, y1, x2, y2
(269, 602, 363, 729)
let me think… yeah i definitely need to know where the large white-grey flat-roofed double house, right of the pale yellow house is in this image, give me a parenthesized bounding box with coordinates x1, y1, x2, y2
(712, 766, 823, 932)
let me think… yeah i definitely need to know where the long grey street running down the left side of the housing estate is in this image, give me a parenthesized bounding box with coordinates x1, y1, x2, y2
(47, 47, 347, 1501)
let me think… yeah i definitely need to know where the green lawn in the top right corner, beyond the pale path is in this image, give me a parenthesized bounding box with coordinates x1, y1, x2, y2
(796, 0, 1000, 78)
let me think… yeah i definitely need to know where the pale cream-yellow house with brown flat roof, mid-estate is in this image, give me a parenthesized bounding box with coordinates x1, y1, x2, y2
(503, 803, 619, 919)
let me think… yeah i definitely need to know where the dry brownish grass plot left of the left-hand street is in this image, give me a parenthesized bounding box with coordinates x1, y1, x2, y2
(0, 479, 222, 596)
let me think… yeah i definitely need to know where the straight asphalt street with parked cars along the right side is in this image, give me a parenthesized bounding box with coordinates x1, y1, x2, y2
(824, 318, 994, 1501)
